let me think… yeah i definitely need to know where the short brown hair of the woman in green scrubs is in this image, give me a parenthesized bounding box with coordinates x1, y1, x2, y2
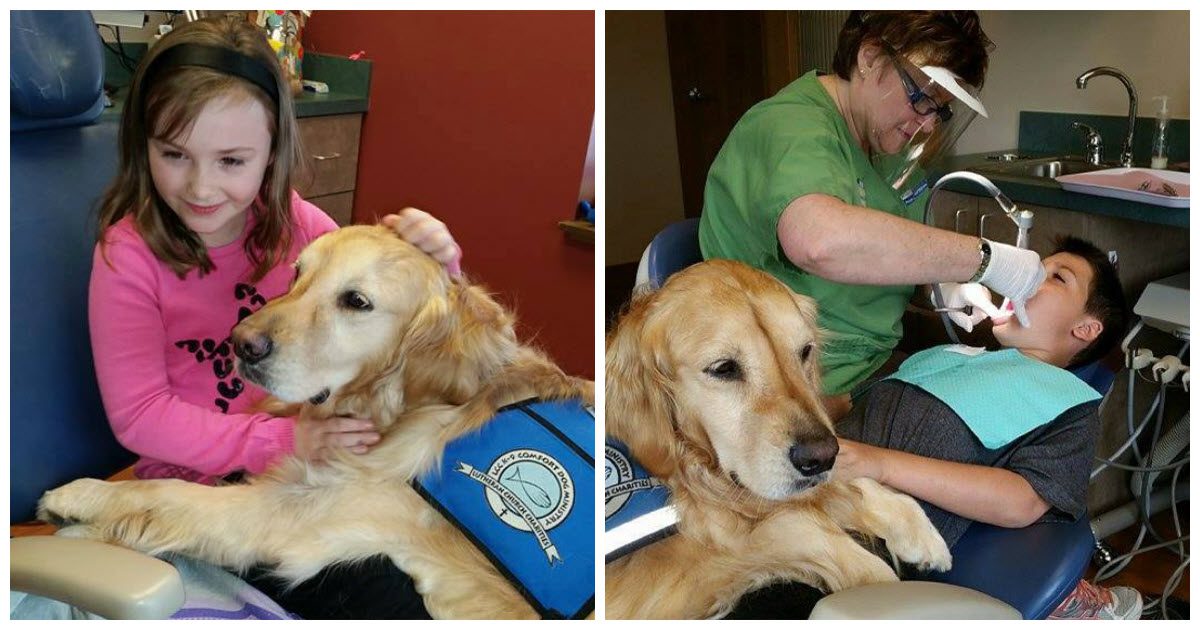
(833, 11, 996, 88)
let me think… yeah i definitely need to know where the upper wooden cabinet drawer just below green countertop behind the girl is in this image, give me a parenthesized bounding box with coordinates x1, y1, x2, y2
(295, 114, 362, 199)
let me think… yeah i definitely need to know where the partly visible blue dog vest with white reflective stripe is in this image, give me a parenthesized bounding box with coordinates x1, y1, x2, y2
(604, 437, 678, 564)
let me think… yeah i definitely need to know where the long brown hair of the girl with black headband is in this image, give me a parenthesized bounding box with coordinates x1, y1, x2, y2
(96, 16, 304, 281)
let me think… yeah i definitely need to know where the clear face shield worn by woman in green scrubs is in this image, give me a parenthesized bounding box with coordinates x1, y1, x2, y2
(871, 43, 988, 190)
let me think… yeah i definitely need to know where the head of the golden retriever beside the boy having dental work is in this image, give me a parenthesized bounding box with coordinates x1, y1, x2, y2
(606, 260, 838, 499)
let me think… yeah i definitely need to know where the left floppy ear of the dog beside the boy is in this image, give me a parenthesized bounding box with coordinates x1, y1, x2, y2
(605, 294, 679, 478)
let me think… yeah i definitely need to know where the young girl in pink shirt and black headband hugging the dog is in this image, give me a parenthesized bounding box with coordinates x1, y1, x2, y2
(88, 13, 460, 616)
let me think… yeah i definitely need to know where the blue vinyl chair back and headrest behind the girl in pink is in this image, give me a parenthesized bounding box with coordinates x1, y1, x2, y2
(8, 11, 134, 522)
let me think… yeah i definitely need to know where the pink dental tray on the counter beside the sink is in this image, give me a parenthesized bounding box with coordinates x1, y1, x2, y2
(1055, 168, 1192, 208)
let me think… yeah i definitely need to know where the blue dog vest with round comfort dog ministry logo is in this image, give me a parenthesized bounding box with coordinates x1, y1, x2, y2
(413, 400, 595, 619)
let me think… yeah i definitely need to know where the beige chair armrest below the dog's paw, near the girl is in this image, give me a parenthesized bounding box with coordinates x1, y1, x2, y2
(8, 536, 184, 619)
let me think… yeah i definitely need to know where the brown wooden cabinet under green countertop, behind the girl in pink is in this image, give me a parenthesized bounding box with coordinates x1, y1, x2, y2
(295, 114, 362, 226)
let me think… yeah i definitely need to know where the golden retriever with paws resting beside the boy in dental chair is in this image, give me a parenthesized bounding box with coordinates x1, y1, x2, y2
(605, 260, 950, 619)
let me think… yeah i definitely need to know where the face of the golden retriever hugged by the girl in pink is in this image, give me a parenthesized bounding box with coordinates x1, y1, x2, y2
(233, 227, 449, 403)
